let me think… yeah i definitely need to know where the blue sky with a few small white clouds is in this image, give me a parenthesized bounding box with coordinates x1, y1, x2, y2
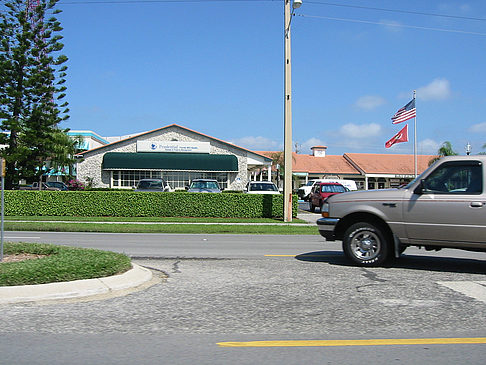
(50, 0, 486, 155)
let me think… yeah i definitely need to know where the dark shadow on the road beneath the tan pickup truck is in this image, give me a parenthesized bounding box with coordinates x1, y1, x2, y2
(295, 251, 486, 274)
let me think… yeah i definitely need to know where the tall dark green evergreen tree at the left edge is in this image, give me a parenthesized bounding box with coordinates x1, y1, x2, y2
(0, 0, 74, 188)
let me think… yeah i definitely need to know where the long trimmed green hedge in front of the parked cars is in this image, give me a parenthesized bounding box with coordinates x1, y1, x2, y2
(5, 190, 298, 218)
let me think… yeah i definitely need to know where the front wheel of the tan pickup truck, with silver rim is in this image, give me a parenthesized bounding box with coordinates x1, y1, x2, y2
(343, 222, 393, 266)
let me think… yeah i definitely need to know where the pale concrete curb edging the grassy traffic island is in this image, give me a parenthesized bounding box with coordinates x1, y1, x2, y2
(0, 264, 152, 304)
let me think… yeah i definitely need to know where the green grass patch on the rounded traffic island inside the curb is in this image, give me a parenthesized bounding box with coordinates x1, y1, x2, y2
(0, 242, 131, 286)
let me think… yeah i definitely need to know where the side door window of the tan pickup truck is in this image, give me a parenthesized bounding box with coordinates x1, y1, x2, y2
(424, 161, 483, 194)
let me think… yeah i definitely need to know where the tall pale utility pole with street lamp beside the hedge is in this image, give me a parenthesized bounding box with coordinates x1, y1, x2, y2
(283, 0, 302, 222)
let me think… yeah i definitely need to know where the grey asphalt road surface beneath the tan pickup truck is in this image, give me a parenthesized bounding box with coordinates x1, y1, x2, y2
(0, 232, 486, 364)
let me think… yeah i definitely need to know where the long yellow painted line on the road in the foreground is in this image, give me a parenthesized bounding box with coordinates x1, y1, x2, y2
(217, 337, 486, 347)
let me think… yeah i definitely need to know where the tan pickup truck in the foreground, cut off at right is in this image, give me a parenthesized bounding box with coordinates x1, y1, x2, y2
(317, 155, 486, 266)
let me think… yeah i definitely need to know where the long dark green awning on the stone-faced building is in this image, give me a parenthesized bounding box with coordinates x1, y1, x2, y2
(102, 152, 238, 172)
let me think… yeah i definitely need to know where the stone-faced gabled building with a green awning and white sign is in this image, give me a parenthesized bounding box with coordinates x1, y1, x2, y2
(76, 124, 272, 190)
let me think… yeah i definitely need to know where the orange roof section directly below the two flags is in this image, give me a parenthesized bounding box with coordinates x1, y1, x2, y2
(344, 153, 436, 175)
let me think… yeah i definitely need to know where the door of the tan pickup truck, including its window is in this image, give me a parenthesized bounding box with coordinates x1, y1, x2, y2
(404, 160, 486, 247)
